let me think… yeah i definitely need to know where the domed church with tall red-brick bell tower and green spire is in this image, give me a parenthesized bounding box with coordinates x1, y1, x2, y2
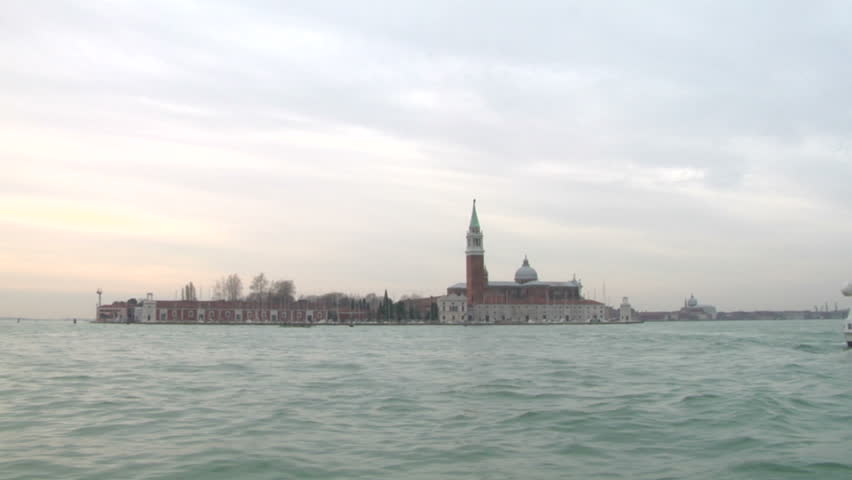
(437, 200, 606, 324)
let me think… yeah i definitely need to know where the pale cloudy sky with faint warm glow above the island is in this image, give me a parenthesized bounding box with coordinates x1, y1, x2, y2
(0, 0, 852, 317)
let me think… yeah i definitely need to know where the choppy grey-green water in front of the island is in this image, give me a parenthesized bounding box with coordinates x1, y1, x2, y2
(0, 320, 852, 479)
